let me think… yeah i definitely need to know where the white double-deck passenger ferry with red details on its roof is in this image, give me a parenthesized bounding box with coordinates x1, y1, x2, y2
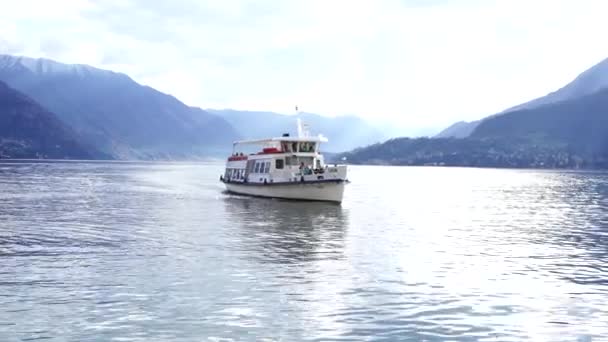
(220, 118, 347, 203)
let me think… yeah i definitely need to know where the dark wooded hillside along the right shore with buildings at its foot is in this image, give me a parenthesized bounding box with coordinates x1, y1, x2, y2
(336, 79, 608, 169)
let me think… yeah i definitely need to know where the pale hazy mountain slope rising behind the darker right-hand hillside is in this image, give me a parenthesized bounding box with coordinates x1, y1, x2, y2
(435, 58, 608, 138)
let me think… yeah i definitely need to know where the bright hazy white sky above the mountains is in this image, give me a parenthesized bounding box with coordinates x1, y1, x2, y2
(0, 0, 608, 134)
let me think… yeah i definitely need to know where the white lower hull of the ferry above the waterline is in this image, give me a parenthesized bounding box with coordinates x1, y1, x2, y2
(224, 181, 344, 203)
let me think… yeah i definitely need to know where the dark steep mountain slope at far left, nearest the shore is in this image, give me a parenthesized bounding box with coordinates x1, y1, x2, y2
(0, 82, 101, 159)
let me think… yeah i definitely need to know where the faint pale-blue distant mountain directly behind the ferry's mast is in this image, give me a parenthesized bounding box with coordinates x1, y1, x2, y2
(207, 109, 386, 152)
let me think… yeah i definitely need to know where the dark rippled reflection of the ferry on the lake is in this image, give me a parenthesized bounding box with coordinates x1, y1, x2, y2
(224, 195, 348, 265)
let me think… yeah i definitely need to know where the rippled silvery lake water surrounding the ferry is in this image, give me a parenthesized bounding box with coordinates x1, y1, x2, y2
(0, 163, 608, 341)
